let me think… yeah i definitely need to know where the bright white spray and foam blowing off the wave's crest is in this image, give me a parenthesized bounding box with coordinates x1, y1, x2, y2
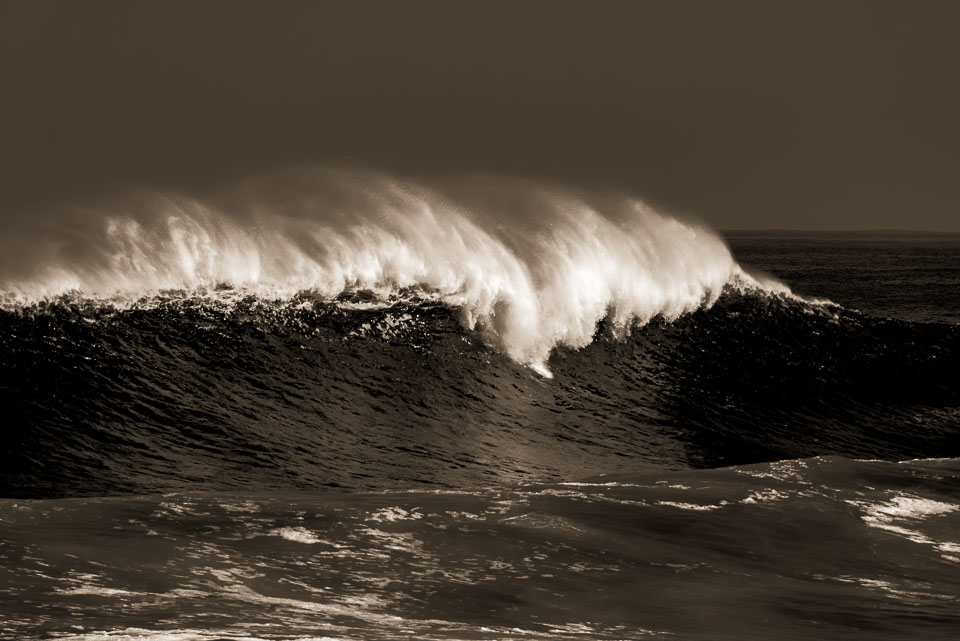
(0, 169, 788, 372)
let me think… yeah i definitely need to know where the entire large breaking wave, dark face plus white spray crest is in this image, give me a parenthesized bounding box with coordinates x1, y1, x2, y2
(0, 170, 960, 496)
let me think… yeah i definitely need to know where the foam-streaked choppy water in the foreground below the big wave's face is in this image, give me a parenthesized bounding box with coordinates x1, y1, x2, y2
(0, 457, 960, 641)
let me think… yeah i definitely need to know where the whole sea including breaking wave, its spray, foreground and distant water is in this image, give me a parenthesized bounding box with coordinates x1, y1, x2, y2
(0, 171, 960, 641)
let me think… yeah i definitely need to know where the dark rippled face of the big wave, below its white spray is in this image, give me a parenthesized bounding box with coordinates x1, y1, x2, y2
(0, 288, 960, 496)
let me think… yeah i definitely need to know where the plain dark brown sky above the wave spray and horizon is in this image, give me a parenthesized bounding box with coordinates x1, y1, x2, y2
(0, 0, 960, 230)
